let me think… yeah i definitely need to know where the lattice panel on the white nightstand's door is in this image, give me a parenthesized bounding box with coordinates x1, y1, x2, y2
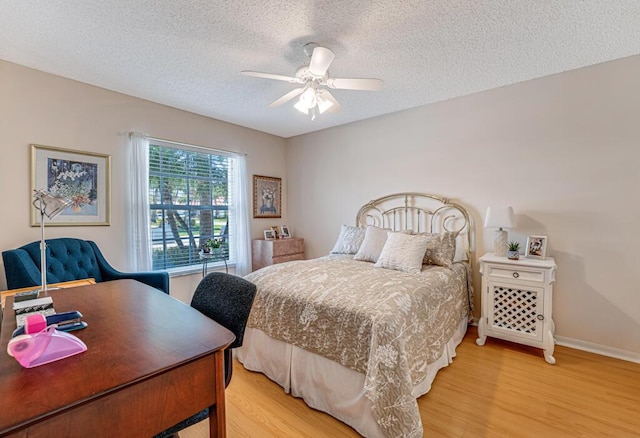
(491, 285, 539, 336)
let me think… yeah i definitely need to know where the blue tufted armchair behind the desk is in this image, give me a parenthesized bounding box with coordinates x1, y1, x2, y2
(2, 237, 169, 294)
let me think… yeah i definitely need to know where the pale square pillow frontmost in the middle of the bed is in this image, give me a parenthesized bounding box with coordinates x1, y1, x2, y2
(374, 233, 429, 274)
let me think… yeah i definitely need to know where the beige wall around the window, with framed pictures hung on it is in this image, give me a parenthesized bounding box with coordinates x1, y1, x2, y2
(0, 61, 287, 299)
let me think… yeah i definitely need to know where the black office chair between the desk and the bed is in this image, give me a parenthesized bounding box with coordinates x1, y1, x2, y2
(155, 272, 256, 438)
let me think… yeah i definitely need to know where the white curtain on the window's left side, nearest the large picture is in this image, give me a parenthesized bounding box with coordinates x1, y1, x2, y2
(125, 133, 153, 272)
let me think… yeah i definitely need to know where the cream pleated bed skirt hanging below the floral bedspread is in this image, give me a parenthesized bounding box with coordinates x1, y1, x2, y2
(234, 319, 467, 438)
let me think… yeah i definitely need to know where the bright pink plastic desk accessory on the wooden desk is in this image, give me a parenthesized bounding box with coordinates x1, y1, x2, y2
(7, 314, 87, 368)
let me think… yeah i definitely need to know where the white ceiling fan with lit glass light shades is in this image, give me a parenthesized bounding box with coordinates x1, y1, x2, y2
(240, 43, 383, 120)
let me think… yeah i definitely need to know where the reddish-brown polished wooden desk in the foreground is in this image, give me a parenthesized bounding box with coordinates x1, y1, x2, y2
(0, 280, 234, 438)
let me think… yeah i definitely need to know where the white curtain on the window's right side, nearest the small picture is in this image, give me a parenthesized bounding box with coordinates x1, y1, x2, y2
(229, 155, 251, 277)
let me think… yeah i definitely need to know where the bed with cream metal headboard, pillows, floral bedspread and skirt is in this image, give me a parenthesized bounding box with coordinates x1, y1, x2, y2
(236, 193, 473, 438)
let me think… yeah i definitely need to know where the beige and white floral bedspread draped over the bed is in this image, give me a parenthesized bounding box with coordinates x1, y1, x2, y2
(246, 255, 473, 438)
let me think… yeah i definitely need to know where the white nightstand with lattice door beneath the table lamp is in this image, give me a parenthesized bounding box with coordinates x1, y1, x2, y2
(476, 253, 557, 364)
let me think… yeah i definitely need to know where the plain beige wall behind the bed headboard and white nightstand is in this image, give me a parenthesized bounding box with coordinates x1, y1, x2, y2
(287, 56, 640, 361)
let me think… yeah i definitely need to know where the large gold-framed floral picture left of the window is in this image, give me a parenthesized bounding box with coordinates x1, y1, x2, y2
(31, 144, 111, 227)
